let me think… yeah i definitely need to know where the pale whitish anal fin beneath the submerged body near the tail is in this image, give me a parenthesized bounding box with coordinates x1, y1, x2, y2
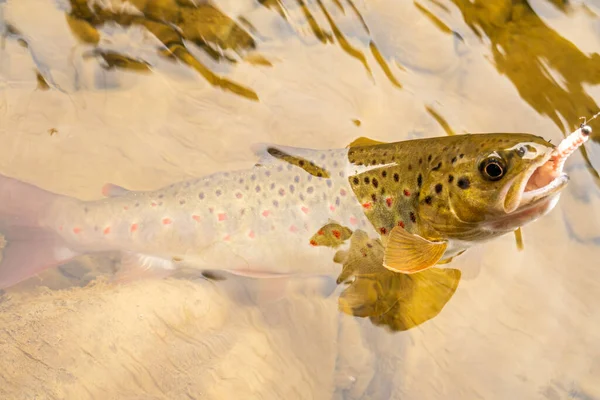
(113, 253, 175, 283)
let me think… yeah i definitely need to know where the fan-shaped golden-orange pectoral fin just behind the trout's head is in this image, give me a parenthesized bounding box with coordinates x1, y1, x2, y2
(383, 227, 448, 274)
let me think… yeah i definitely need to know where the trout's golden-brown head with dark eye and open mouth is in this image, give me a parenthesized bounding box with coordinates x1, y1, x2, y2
(419, 134, 568, 241)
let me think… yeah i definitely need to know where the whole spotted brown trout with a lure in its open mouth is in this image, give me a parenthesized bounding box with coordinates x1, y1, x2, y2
(0, 126, 591, 288)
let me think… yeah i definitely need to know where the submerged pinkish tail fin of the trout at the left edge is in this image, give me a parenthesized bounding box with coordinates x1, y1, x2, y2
(0, 175, 77, 289)
